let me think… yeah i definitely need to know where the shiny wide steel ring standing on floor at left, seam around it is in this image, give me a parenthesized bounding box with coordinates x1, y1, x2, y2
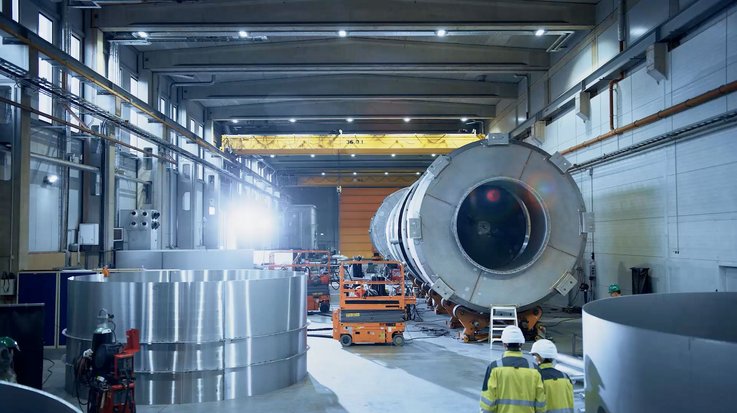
(65, 270, 307, 404)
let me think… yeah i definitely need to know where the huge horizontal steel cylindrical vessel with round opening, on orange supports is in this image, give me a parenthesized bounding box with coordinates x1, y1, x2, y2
(371, 138, 586, 312)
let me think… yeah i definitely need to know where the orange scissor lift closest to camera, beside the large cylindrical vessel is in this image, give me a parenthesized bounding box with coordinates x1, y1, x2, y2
(333, 261, 416, 347)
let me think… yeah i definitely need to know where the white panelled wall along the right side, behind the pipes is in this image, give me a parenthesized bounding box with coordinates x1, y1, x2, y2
(516, 0, 737, 297)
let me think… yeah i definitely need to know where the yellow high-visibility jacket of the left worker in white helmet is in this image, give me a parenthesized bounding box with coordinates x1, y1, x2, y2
(480, 351, 545, 413)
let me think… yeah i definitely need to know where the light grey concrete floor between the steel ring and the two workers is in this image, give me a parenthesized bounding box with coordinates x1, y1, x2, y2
(44, 304, 583, 413)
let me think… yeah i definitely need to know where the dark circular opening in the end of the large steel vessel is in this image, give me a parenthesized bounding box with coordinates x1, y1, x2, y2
(455, 179, 548, 273)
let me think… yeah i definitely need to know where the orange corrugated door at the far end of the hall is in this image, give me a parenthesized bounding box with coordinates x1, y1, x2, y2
(339, 188, 397, 257)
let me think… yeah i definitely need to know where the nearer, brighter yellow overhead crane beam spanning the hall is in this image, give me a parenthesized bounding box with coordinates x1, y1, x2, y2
(222, 133, 485, 155)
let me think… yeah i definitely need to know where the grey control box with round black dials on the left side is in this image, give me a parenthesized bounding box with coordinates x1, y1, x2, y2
(119, 209, 161, 250)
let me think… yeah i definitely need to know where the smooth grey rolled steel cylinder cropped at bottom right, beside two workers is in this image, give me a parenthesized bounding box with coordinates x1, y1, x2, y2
(583, 292, 737, 413)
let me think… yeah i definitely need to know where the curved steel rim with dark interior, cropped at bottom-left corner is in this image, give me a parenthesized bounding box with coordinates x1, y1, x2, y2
(0, 381, 82, 413)
